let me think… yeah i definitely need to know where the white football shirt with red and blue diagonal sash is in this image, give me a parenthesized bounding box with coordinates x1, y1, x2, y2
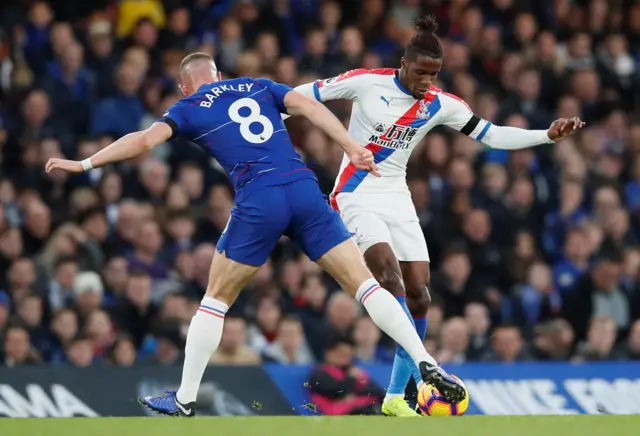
(295, 68, 491, 204)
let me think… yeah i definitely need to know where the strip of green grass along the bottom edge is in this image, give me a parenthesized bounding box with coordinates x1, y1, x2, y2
(0, 415, 640, 436)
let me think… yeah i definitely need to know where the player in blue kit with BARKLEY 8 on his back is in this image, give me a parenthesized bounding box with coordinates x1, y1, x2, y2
(46, 53, 465, 416)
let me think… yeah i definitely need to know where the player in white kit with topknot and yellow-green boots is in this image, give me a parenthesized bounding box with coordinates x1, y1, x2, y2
(295, 16, 584, 417)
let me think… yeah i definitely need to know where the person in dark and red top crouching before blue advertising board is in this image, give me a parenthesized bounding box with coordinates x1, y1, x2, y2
(309, 334, 384, 415)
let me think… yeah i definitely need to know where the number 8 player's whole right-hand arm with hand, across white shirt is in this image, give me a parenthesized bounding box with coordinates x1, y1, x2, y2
(284, 91, 379, 176)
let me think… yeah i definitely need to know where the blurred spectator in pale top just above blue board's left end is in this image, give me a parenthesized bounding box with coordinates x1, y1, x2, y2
(262, 316, 314, 365)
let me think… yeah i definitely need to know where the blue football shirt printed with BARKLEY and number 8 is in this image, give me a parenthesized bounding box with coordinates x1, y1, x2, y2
(160, 77, 315, 200)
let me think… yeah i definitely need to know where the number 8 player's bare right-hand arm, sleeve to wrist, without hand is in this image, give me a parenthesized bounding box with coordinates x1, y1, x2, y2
(284, 91, 362, 155)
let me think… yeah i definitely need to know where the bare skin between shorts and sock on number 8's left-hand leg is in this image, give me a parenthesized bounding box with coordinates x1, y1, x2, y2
(206, 252, 260, 306)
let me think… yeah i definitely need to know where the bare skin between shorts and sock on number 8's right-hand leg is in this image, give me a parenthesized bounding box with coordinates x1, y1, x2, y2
(316, 238, 373, 297)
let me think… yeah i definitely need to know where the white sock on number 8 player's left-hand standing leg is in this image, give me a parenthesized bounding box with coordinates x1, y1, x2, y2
(177, 297, 229, 404)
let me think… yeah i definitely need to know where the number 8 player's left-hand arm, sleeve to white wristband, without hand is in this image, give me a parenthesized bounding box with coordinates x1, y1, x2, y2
(89, 121, 173, 168)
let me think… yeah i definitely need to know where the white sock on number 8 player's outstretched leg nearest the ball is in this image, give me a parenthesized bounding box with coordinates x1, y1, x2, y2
(356, 278, 438, 366)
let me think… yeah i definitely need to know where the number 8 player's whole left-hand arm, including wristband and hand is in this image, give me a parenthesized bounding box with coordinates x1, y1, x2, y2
(45, 122, 173, 173)
